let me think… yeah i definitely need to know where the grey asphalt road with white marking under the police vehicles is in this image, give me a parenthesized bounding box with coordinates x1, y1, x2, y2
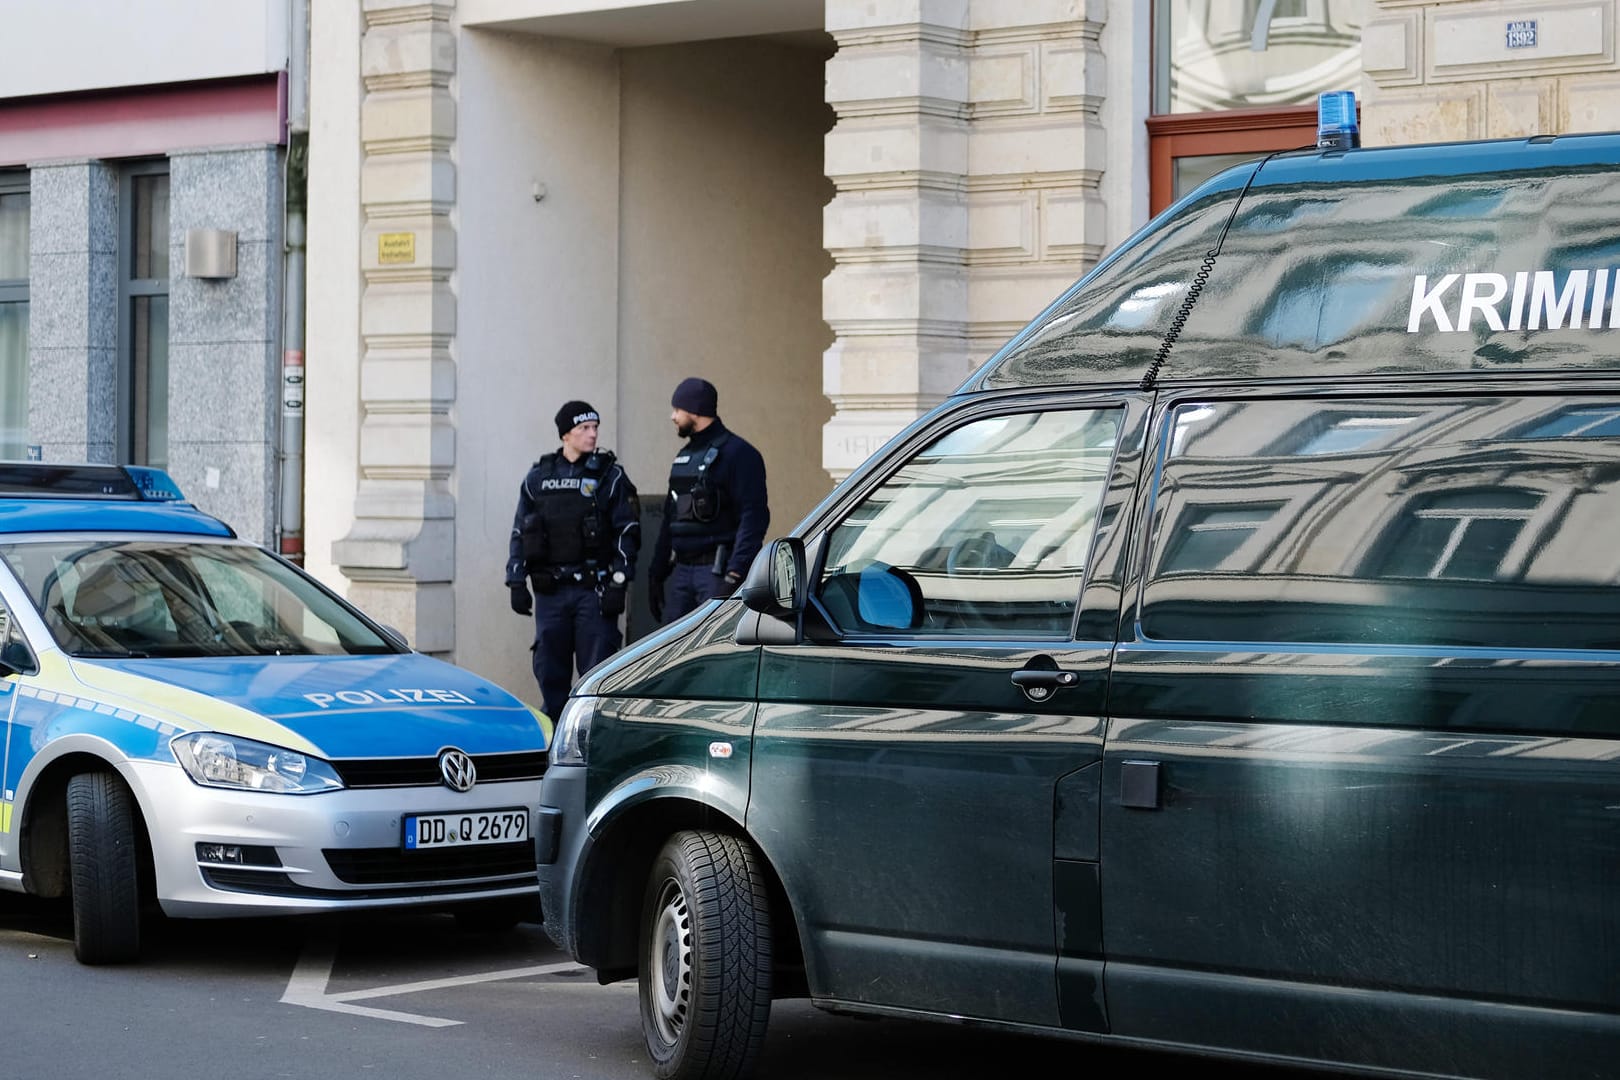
(0, 892, 1325, 1080)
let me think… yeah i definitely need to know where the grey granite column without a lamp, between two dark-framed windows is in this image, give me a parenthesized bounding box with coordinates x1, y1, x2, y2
(28, 162, 118, 461)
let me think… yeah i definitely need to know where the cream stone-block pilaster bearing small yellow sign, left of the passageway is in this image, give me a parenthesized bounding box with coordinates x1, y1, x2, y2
(332, 0, 457, 656)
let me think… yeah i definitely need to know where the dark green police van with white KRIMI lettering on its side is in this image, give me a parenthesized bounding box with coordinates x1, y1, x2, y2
(538, 105, 1620, 1078)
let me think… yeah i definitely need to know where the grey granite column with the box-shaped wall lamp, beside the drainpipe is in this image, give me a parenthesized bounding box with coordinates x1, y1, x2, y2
(168, 146, 282, 542)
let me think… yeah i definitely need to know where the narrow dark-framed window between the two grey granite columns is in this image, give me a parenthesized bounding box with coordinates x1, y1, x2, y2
(118, 162, 168, 468)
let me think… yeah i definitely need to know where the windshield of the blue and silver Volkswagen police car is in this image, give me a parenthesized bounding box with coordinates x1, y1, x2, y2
(0, 539, 400, 659)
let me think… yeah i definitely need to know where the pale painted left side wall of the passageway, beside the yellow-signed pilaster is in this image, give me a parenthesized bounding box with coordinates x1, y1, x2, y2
(452, 31, 622, 703)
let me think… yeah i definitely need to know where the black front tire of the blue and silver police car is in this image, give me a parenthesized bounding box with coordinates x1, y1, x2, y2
(68, 772, 141, 963)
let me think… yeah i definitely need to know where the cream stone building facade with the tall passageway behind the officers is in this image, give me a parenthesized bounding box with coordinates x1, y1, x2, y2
(294, 0, 1620, 702)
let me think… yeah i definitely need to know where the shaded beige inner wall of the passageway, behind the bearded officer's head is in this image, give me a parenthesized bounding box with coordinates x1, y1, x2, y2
(619, 39, 833, 536)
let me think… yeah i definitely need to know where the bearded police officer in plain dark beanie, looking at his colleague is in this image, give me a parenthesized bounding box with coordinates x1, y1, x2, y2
(648, 379, 771, 622)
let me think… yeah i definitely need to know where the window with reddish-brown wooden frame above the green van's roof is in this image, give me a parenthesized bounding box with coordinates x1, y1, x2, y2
(1147, 0, 1362, 214)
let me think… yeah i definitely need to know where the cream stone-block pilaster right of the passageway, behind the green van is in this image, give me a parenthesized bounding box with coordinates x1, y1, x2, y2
(823, 0, 1106, 478)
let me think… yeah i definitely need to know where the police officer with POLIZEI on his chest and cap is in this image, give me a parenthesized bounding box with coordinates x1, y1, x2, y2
(505, 402, 642, 717)
